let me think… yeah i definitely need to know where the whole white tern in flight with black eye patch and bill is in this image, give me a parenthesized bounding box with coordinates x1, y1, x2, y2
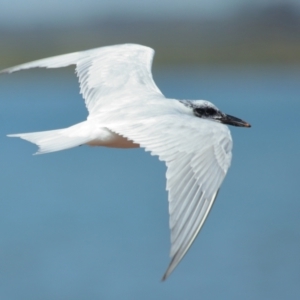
(0, 44, 251, 281)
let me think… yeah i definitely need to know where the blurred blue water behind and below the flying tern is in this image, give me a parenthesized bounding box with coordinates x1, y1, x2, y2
(0, 66, 300, 300)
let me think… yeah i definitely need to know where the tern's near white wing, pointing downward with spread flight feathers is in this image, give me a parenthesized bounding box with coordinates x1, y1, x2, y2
(108, 113, 232, 280)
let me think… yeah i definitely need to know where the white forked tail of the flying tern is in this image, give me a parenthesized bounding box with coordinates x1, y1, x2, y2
(7, 122, 92, 154)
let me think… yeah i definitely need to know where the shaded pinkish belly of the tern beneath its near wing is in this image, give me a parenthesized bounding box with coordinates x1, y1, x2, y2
(87, 128, 140, 148)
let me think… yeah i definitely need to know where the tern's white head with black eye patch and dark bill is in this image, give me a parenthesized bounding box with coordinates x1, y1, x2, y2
(180, 100, 251, 127)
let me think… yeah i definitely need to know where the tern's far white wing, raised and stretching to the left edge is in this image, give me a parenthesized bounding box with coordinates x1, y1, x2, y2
(0, 44, 163, 113)
